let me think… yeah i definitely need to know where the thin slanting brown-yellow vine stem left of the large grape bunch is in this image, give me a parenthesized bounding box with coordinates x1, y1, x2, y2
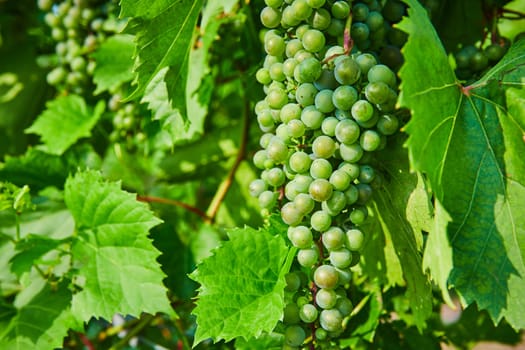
(206, 81, 250, 223)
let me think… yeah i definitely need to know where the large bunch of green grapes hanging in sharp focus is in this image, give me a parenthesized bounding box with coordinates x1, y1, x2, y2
(249, 0, 405, 349)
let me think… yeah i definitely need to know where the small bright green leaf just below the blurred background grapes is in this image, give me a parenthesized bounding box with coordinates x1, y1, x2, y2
(25, 95, 105, 155)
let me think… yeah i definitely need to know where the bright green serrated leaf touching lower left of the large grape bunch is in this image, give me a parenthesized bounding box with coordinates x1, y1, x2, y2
(190, 227, 294, 344)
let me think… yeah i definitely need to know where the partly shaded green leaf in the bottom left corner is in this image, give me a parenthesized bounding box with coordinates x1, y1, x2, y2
(0, 281, 82, 350)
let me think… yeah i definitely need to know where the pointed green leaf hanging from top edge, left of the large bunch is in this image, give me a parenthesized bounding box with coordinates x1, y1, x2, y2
(121, 0, 202, 120)
